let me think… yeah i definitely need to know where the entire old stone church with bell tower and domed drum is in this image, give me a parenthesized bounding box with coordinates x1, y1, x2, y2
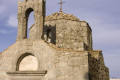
(0, 0, 109, 80)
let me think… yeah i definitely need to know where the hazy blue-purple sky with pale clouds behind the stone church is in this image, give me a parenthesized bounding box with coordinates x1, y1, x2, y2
(0, 0, 120, 78)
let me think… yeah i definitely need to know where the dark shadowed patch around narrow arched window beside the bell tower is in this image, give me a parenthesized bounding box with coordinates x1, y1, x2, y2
(44, 25, 56, 44)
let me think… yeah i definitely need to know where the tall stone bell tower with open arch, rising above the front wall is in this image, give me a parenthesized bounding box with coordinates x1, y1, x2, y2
(17, 0, 45, 40)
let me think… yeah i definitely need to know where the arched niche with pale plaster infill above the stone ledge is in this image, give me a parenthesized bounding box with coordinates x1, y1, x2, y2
(16, 53, 38, 71)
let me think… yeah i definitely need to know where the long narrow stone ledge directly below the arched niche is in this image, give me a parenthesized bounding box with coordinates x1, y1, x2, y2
(6, 70, 47, 76)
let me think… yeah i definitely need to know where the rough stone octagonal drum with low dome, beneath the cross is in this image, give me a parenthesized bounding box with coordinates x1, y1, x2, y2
(44, 13, 92, 50)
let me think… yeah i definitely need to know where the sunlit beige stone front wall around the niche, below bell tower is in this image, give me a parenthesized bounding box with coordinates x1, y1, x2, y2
(0, 39, 89, 80)
